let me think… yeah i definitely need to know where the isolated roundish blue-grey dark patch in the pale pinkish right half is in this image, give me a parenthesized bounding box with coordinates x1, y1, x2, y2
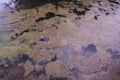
(81, 44, 97, 57)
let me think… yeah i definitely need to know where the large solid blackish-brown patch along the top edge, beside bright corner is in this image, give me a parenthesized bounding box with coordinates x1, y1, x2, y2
(13, 0, 65, 10)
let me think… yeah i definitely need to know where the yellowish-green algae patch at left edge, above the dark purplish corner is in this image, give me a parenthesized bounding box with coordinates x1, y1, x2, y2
(0, 44, 30, 59)
